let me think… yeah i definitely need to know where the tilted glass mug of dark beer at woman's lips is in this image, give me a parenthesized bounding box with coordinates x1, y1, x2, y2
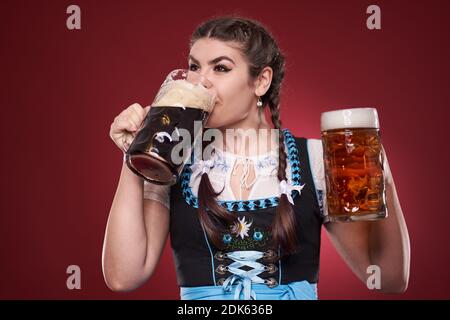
(125, 69, 216, 185)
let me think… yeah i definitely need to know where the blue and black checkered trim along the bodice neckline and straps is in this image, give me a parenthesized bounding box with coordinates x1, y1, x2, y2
(180, 129, 301, 211)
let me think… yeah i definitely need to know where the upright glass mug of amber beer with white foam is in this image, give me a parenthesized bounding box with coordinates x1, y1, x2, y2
(321, 108, 387, 221)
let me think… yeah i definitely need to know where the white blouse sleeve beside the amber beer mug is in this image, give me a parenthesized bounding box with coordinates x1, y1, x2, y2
(307, 139, 328, 222)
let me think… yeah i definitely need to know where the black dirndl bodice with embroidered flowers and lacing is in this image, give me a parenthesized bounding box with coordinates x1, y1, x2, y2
(170, 131, 322, 287)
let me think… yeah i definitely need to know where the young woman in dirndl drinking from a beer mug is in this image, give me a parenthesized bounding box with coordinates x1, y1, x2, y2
(103, 17, 410, 299)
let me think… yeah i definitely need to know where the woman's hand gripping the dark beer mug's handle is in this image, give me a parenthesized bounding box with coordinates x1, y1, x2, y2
(109, 103, 150, 152)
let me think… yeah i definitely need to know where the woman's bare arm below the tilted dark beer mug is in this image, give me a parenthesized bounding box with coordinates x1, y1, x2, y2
(102, 162, 169, 291)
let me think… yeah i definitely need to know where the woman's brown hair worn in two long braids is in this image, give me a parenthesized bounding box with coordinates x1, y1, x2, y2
(190, 16, 297, 254)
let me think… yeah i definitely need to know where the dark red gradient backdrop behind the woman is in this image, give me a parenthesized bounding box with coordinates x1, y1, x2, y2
(0, 0, 450, 299)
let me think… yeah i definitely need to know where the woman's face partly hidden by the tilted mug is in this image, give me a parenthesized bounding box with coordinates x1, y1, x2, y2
(189, 38, 257, 128)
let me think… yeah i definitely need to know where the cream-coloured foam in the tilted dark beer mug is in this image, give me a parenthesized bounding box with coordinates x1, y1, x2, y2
(152, 80, 214, 112)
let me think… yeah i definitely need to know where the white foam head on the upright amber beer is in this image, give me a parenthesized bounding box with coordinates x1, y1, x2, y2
(320, 108, 380, 131)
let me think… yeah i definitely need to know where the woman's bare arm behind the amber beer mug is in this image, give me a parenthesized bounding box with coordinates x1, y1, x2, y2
(325, 147, 410, 293)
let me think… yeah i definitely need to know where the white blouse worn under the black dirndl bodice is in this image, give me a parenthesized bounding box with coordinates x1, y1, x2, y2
(144, 139, 326, 215)
